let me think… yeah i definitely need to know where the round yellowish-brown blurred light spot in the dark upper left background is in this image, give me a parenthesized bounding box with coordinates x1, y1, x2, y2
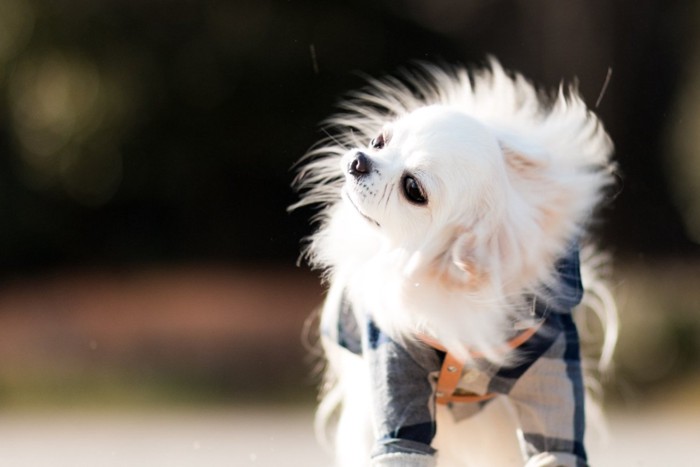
(8, 50, 127, 205)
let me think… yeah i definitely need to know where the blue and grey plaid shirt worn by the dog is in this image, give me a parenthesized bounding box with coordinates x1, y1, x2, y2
(322, 250, 588, 467)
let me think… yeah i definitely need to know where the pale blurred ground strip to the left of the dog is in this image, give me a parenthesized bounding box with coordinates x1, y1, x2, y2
(0, 407, 325, 467)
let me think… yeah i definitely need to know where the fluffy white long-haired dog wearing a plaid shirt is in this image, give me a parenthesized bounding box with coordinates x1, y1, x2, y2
(292, 59, 617, 467)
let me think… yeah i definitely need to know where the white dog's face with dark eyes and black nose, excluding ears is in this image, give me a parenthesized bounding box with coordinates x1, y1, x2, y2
(341, 106, 507, 260)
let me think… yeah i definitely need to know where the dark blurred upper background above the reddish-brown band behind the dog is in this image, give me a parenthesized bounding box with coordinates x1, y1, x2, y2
(0, 0, 693, 272)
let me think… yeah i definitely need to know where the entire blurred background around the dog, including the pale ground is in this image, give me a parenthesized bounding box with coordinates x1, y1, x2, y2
(0, 0, 700, 467)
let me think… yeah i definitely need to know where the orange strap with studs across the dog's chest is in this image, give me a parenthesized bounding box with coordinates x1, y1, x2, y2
(419, 322, 542, 404)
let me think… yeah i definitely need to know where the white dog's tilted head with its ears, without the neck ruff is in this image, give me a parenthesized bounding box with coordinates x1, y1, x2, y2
(341, 105, 546, 286)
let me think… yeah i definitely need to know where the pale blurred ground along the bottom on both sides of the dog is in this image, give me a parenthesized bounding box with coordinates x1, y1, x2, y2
(0, 406, 700, 467)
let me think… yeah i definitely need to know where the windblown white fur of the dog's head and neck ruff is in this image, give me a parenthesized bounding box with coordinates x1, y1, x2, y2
(294, 61, 614, 466)
